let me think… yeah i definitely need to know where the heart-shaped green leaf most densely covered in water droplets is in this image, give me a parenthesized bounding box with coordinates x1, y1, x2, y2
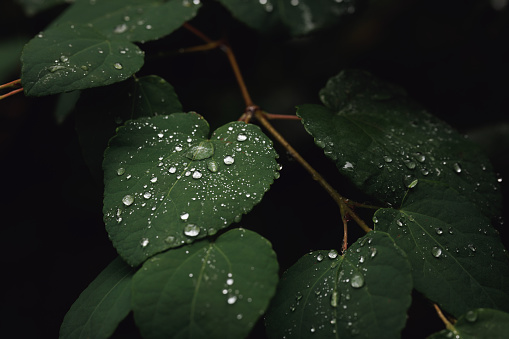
(103, 113, 279, 266)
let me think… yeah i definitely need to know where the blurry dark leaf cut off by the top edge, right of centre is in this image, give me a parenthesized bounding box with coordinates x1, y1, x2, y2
(219, 0, 358, 35)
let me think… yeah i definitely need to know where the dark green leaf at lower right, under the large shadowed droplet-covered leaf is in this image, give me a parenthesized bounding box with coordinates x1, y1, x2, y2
(374, 181, 509, 316)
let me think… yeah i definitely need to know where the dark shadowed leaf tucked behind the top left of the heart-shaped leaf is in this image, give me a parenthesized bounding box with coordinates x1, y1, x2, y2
(76, 75, 182, 181)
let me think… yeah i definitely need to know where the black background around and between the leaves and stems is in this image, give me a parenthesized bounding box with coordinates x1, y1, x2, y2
(0, 0, 509, 338)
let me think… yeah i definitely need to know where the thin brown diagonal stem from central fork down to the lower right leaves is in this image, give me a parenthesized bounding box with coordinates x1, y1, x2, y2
(254, 110, 372, 235)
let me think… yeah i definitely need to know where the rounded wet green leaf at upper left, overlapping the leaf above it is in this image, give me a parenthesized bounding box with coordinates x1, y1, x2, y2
(21, 24, 144, 96)
